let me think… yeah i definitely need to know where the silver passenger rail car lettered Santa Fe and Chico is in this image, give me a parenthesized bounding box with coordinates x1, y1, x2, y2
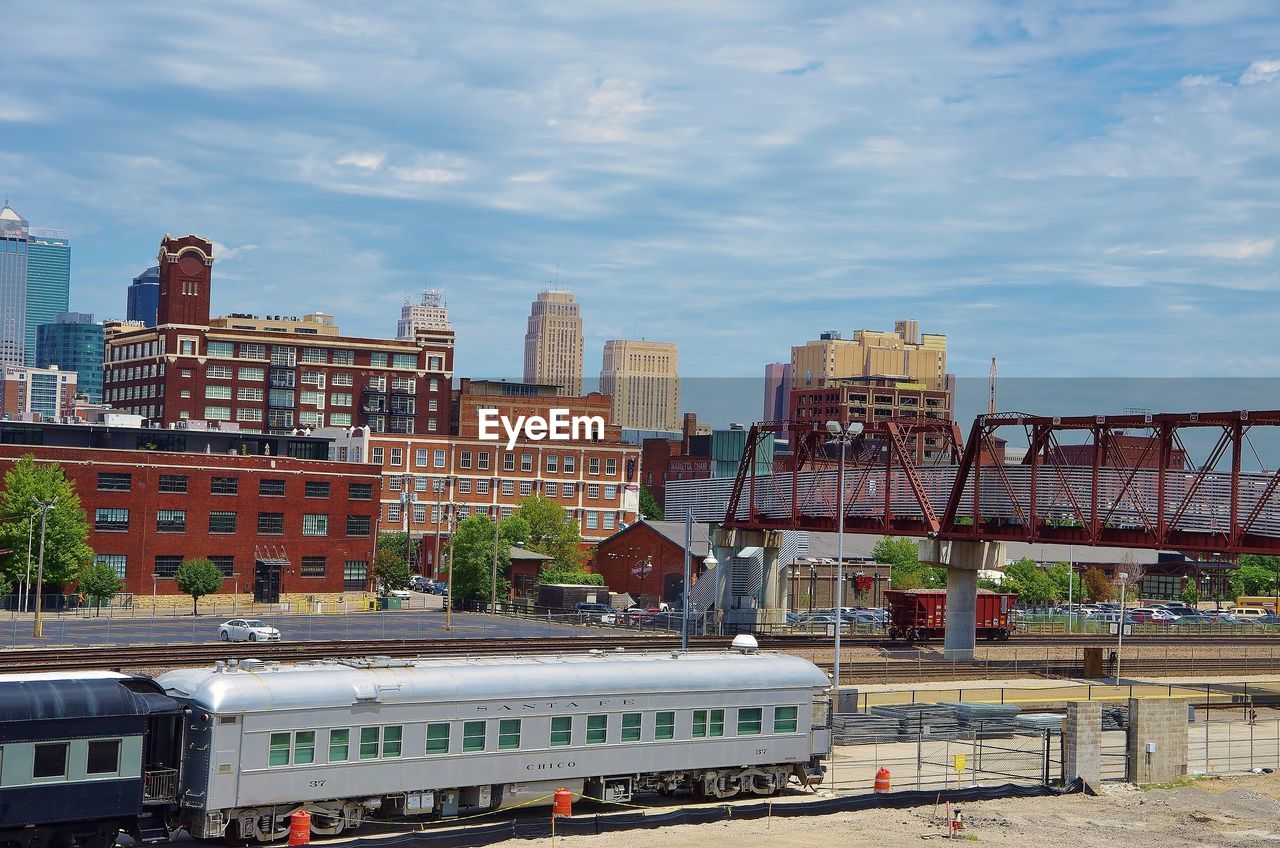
(160, 651, 831, 843)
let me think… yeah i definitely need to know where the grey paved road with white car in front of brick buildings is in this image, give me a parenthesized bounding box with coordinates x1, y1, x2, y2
(0, 610, 627, 648)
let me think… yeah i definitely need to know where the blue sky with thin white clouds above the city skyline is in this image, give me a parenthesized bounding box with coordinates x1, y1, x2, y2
(0, 0, 1280, 389)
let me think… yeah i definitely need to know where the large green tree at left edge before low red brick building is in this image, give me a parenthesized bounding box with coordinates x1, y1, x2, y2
(0, 453, 93, 587)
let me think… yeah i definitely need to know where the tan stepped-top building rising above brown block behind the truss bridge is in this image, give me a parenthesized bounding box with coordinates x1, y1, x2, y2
(791, 320, 947, 391)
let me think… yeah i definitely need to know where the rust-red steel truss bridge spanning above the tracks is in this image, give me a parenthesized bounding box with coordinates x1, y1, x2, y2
(667, 411, 1280, 556)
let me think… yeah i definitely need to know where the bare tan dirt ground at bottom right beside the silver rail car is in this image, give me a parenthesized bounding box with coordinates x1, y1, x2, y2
(500, 774, 1280, 848)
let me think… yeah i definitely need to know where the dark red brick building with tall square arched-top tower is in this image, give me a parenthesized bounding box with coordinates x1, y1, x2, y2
(104, 236, 453, 436)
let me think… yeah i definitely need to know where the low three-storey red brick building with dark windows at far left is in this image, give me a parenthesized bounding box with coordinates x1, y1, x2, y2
(0, 421, 381, 596)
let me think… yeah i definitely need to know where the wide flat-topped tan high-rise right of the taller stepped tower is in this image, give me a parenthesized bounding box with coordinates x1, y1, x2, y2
(600, 338, 680, 432)
